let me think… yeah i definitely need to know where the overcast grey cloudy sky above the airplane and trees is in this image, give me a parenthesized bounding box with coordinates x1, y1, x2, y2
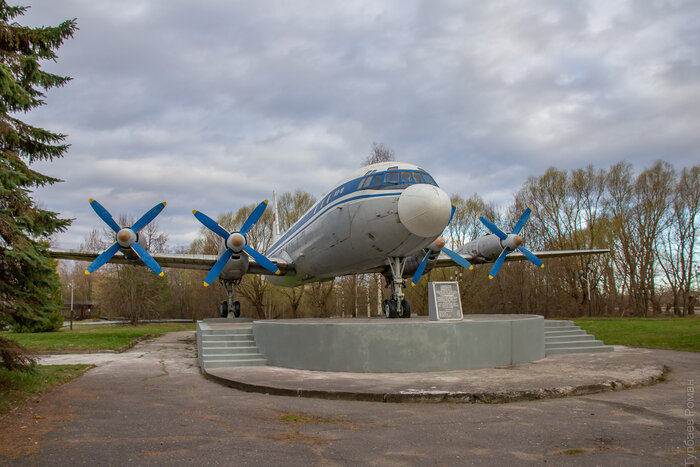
(20, 0, 700, 248)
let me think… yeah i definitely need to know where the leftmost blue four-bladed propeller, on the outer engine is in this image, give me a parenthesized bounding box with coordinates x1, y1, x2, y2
(85, 199, 166, 276)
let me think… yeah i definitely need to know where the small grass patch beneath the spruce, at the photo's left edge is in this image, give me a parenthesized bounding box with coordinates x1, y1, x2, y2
(0, 365, 92, 416)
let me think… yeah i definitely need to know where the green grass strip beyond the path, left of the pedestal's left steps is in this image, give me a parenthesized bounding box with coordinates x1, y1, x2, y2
(0, 323, 195, 352)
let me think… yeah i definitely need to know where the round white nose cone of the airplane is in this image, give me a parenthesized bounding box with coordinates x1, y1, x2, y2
(399, 184, 452, 238)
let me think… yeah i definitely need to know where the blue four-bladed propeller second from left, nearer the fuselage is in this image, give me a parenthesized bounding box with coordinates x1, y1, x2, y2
(192, 200, 280, 287)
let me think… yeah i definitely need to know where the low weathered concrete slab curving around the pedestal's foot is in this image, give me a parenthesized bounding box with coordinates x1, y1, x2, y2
(204, 346, 667, 403)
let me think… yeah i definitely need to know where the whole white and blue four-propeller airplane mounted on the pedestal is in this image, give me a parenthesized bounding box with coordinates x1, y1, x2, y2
(49, 161, 610, 318)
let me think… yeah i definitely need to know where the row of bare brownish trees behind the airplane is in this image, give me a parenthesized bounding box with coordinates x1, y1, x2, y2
(62, 161, 700, 322)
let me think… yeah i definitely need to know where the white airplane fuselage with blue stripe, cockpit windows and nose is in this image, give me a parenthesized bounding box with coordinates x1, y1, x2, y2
(267, 162, 451, 286)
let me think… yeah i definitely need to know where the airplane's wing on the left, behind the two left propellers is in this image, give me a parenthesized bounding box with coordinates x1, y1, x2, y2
(49, 248, 296, 276)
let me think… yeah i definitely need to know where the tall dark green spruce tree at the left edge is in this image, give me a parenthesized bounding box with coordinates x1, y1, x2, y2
(0, 0, 77, 366)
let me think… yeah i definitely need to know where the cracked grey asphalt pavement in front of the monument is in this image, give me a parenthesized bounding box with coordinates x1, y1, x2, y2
(0, 332, 700, 466)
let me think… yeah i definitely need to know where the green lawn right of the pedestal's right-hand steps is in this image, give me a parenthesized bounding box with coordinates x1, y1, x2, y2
(573, 316, 700, 352)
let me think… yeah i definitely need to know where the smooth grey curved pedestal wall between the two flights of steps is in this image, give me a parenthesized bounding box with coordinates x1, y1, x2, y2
(252, 314, 545, 373)
